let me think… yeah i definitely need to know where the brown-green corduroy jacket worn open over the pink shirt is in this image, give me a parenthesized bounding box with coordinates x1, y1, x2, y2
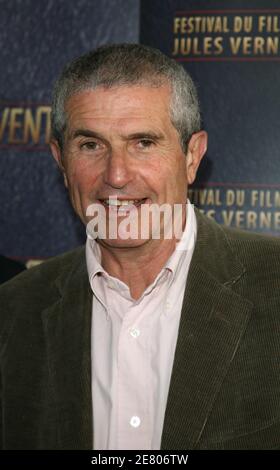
(0, 212, 280, 450)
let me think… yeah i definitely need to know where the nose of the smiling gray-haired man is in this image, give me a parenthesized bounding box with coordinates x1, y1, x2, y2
(104, 150, 132, 188)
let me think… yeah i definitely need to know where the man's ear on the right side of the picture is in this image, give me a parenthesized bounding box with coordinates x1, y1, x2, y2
(186, 131, 208, 184)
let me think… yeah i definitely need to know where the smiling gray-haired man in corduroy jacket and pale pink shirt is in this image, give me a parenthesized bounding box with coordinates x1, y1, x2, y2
(0, 45, 280, 449)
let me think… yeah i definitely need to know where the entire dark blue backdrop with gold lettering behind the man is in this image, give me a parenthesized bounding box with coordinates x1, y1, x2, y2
(0, 0, 280, 260)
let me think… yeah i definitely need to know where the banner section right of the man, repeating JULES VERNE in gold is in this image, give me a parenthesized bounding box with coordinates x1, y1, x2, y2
(140, 0, 280, 236)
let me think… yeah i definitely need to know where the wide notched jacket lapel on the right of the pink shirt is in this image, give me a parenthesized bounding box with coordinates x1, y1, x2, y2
(161, 212, 252, 450)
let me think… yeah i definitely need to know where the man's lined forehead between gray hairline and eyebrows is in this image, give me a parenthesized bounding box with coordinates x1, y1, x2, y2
(65, 85, 171, 127)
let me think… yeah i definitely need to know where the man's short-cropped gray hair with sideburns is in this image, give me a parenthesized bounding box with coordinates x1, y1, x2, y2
(51, 44, 201, 150)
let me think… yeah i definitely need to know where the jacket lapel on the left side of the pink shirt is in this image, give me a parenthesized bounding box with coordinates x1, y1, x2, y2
(42, 250, 93, 449)
